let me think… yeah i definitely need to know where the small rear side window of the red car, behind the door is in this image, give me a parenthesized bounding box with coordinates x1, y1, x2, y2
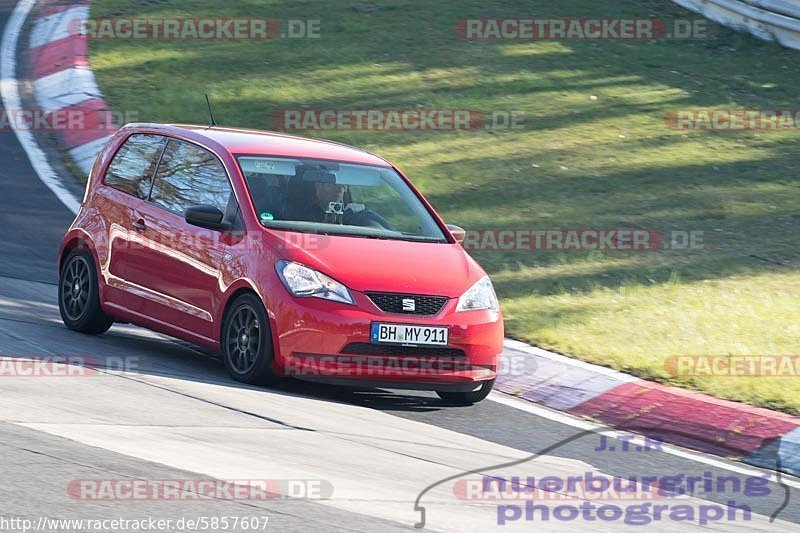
(104, 134, 167, 199)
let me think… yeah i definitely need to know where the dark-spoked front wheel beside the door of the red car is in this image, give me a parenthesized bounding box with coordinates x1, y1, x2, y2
(220, 294, 280, 385)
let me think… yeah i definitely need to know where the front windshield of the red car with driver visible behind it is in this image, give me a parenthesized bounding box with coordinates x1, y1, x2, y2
(237, 156, 447, 242)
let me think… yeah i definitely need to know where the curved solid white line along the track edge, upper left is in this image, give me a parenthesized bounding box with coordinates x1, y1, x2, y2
(0, 0, 80, 213)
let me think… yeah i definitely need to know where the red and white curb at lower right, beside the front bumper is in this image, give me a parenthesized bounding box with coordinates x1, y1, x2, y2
(495, 340, 800, 475)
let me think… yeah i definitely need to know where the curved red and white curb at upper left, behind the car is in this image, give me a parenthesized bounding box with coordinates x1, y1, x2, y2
(28, 2, 117, 174)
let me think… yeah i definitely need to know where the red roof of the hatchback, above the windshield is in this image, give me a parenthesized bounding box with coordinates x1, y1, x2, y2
(127, 124, 390, 167)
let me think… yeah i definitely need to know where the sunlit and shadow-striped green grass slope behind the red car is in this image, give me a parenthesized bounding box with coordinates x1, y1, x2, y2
(90, 0, 800, 414)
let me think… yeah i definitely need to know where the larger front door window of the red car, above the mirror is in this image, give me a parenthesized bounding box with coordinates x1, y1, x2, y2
(150, 139, 232, 215)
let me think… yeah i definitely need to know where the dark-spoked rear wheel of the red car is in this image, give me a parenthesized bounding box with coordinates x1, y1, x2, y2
(58, 251, 114, 335)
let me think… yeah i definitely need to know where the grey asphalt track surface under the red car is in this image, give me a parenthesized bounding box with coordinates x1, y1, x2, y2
(0, 2, 800, 531)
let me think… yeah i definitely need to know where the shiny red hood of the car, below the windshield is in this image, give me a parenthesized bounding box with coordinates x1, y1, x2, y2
(270, 231, 486, 298)
